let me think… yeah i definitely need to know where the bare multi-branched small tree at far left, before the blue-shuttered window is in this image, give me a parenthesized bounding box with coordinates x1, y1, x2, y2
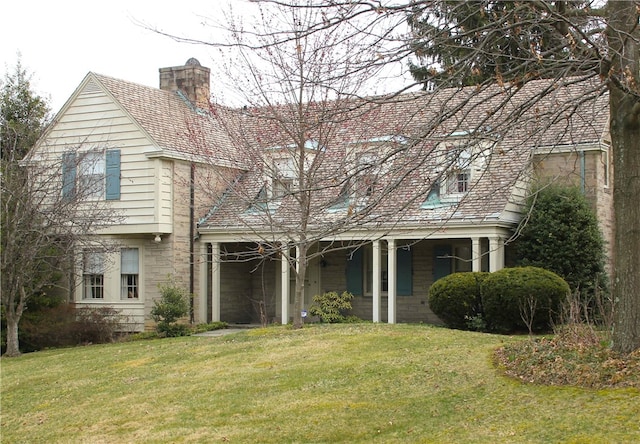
(1, 132, 117, 356)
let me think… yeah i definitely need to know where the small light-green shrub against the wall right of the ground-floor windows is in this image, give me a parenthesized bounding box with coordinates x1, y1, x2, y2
(151, 281, 190, 337)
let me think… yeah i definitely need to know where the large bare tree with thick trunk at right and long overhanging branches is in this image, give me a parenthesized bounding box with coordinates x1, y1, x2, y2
(149, 0, 640, 352)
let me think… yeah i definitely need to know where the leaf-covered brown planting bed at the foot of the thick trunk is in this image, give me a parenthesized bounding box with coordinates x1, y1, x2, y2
(494, 327, 640, 389)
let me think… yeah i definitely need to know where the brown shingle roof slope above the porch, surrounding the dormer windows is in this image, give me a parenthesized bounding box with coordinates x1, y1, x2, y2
(200, 79, 608, 232)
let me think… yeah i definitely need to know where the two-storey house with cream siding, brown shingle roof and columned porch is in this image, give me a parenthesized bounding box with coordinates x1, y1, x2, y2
(27, 59, 612, 330)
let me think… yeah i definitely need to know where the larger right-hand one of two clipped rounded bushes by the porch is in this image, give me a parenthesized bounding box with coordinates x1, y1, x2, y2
(480, 267, 570, 333)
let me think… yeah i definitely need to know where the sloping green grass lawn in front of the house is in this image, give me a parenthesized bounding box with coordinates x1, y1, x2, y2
(1, 324, 640, 444)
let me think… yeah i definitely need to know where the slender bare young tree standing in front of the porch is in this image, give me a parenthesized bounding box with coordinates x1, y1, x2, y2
(196, 5, 440, 327)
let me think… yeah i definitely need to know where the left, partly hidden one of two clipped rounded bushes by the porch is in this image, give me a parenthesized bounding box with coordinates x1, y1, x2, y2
(429, 272, 489, 330)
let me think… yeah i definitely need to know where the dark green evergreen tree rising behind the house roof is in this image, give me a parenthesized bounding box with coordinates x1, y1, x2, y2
(408, 0, 591, 85)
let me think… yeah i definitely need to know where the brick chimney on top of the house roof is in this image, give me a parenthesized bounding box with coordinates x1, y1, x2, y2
(160, 57, 211, 109)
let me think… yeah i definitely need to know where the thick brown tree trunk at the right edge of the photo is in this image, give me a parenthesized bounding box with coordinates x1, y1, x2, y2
(608, 1, 640, 353)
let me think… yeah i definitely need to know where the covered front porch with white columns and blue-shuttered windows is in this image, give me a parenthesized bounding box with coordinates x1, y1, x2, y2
(196, 227, 510, 324)
